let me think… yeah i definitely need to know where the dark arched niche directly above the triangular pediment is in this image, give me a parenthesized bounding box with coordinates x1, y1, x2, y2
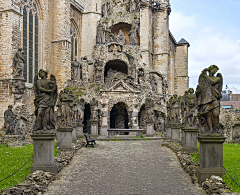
(104, 60, 128, 83)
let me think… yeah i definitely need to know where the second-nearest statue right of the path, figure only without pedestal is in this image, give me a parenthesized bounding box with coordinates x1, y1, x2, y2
(185, 88, 197, 127)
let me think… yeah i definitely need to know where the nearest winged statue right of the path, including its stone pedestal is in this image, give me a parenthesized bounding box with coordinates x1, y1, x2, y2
(196, 65, 226, 181)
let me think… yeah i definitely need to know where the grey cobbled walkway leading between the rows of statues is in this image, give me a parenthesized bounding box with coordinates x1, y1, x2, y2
(45, 141, 205, 195)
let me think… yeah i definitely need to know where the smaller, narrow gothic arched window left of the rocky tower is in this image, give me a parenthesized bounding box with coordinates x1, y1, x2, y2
(70, 21, 78, 61)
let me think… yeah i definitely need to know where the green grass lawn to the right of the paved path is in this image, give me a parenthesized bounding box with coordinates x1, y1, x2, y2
(191, 143, 240, 193)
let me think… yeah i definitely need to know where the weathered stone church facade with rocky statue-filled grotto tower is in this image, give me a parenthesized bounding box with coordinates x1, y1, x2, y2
(0, 0, 190, 135)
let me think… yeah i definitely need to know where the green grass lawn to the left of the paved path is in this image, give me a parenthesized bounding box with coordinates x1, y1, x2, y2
(0, 144, 58, 191)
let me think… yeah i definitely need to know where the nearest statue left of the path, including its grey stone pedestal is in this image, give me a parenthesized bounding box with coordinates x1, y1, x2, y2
(31, 69, 58, 173)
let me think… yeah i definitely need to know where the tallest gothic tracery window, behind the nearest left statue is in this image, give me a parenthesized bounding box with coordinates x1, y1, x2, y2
(21, 0, 39, 83)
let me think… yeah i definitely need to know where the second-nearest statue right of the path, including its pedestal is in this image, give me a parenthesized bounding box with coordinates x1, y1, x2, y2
(182, 88, 198, 153)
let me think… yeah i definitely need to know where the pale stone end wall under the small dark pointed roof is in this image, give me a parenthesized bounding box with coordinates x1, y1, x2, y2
(174, 44, 189, 95)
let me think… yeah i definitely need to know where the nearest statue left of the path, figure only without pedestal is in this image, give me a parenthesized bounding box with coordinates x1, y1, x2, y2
(33, 69, 58, 133)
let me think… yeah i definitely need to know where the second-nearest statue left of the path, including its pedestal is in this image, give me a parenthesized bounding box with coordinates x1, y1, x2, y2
(57, 87, 74, 151)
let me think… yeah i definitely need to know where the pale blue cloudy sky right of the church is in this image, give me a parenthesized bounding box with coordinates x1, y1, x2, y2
(170, 0, 240, 89)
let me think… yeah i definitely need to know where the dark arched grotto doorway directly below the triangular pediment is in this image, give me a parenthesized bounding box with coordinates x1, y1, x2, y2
(110, 102, 129, 129)
